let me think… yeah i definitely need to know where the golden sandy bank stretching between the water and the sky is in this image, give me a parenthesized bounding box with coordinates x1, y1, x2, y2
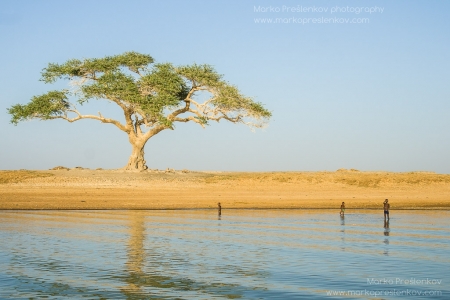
(0, 169, 450, 210)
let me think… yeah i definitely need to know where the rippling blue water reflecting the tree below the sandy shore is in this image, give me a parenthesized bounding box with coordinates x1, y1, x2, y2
(0, 210, 450, 299)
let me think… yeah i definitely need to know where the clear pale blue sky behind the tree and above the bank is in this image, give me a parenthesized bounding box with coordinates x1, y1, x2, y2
(0, 0, 450, 173)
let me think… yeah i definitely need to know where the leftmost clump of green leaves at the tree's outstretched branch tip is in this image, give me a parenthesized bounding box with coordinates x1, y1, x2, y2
(8, 90, 70, 125)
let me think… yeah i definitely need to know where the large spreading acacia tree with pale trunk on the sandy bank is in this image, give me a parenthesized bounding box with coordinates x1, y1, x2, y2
(8, 52, 271, 170)
